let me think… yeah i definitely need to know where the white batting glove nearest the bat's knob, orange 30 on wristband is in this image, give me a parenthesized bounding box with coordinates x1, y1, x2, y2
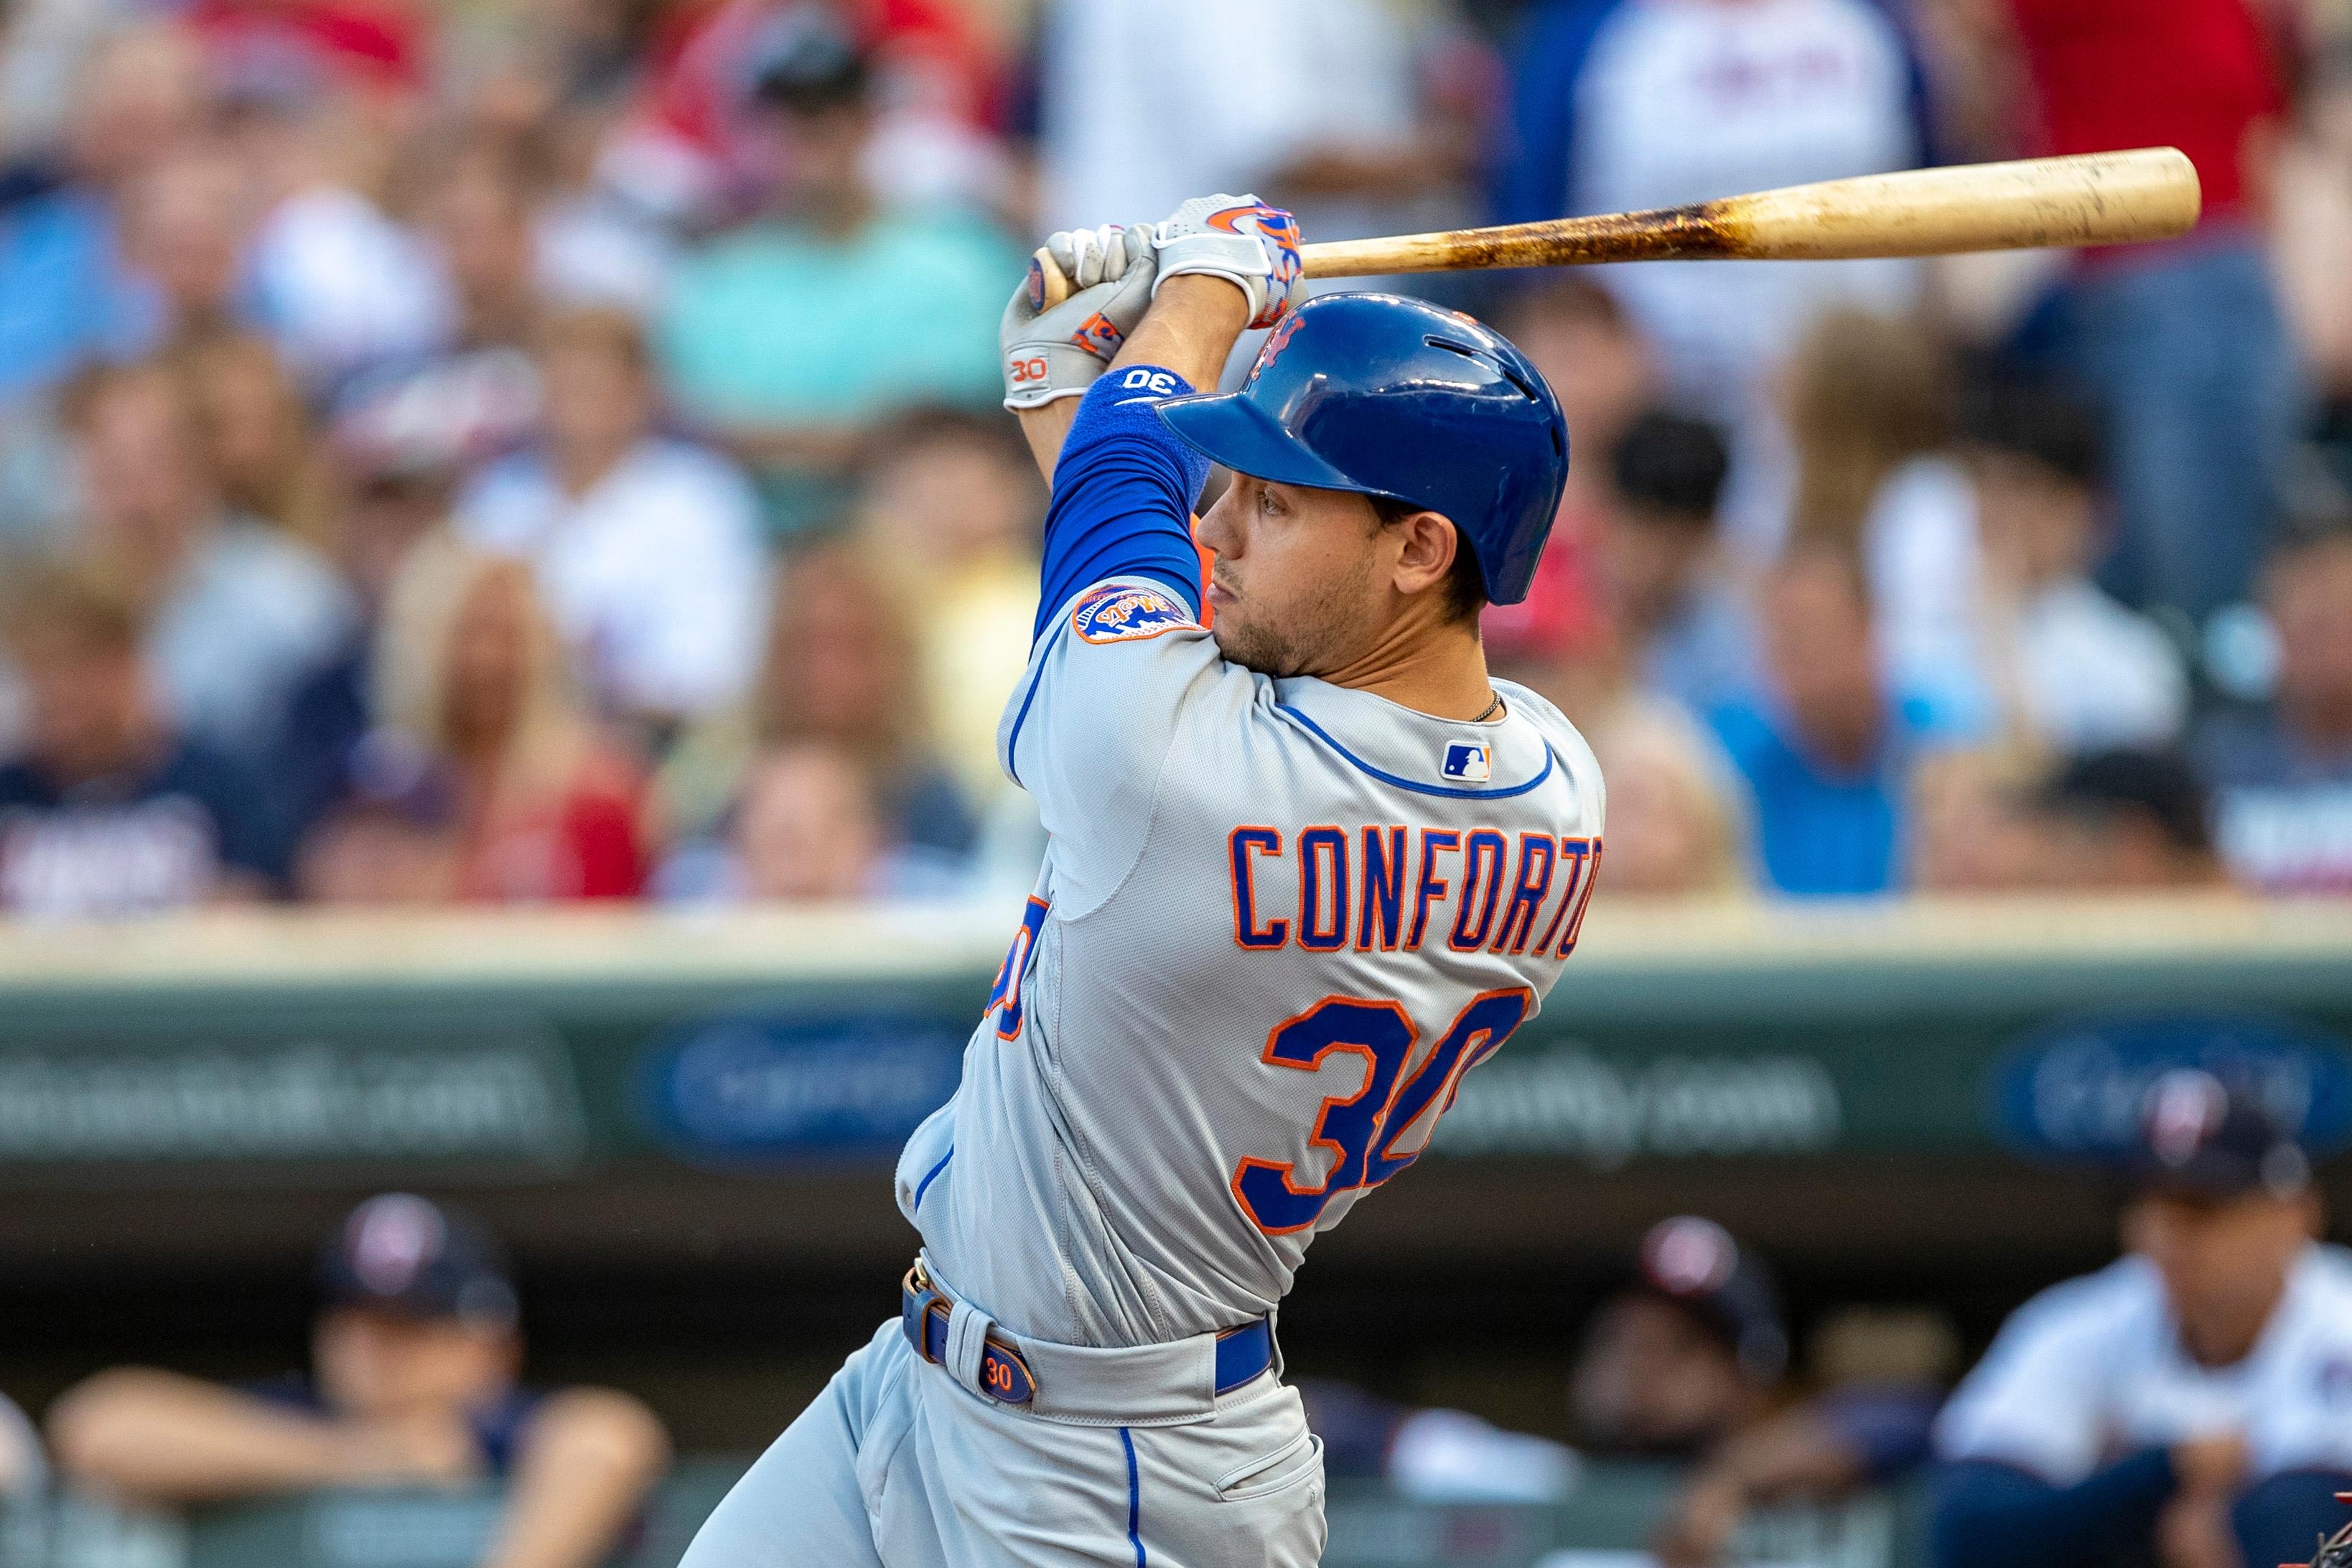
(997, 223, 1157, 411)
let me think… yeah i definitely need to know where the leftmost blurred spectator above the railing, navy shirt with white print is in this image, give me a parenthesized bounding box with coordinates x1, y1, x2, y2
(0, 564, 282, 919)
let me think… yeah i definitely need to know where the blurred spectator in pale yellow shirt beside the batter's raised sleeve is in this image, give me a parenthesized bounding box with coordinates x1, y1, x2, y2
(856, 409, 1045, 802)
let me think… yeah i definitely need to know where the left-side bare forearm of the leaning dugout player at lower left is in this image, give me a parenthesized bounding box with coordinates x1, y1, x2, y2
(50, 1368, 363, 1502)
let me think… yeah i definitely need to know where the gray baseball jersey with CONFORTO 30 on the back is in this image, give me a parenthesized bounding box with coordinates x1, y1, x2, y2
(896, 576, 1602, 1347)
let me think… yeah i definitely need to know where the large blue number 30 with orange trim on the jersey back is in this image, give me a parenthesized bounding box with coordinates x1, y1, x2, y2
(1233, 985, 1536, 1236)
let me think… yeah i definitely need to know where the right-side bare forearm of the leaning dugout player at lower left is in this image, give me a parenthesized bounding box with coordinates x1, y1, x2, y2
(485, 1389, 671, 1568)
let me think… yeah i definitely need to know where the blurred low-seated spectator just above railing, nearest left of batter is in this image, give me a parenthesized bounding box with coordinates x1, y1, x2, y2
(656, 740, 966, 902)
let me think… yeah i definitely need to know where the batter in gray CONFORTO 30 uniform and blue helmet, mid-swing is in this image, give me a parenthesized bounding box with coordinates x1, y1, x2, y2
(684, 197, 1602, 1568)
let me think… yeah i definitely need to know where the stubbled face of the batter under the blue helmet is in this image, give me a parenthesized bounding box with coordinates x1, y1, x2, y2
(1200, 475, 1399, 675)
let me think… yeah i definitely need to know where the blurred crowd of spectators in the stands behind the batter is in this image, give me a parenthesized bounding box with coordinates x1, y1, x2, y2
(0, 0, 2352, 917)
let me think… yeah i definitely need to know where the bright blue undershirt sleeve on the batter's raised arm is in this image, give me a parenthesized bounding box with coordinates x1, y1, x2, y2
(1032, 365, 1209, 635)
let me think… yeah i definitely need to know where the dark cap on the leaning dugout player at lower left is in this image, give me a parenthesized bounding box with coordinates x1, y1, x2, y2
(317, 1192, 520, 1328)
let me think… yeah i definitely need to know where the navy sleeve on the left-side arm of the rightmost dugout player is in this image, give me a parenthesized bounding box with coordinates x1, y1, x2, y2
(1928, 1448, 2173, 1568)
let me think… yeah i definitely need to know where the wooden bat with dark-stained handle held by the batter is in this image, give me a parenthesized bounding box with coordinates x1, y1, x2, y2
(1030, 148, 2204, 308)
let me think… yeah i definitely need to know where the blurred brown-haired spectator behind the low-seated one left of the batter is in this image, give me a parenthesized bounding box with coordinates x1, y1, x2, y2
(656, 541, 976, 856)
